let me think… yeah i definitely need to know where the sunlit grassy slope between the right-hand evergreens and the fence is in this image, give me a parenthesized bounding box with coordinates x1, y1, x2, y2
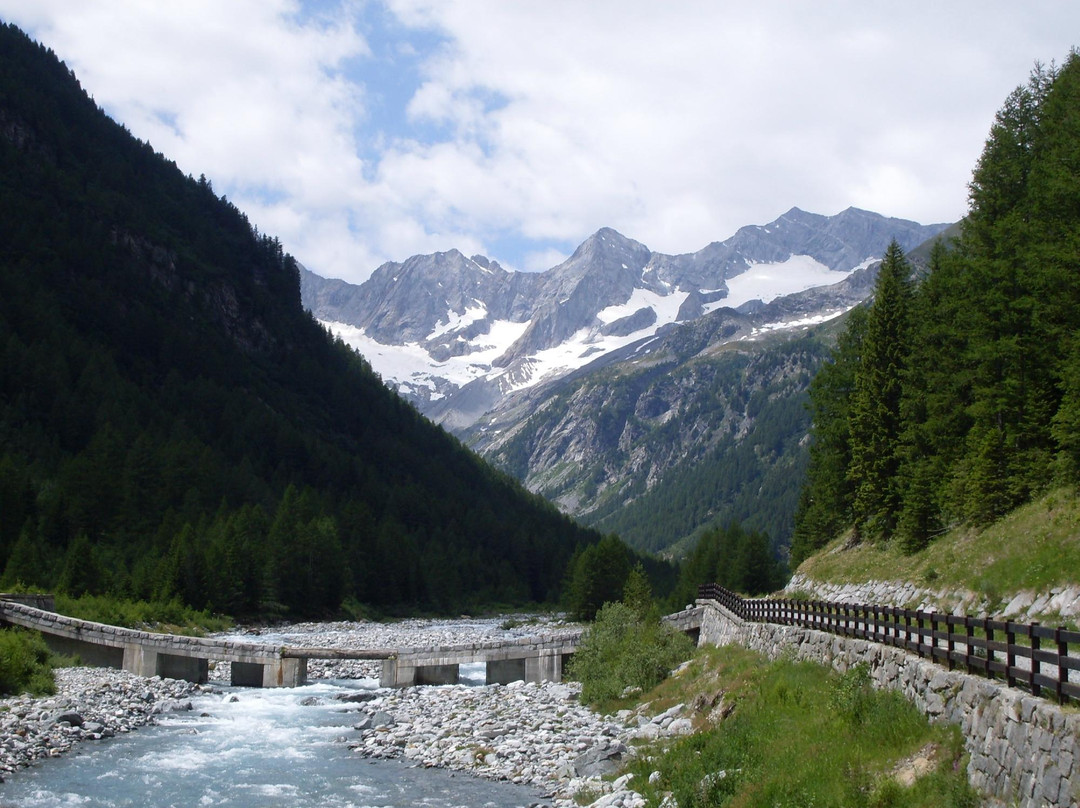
(798, 488, 1080, 611)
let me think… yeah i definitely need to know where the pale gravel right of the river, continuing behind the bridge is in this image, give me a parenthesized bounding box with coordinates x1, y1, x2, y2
(222, 616, 690, 808)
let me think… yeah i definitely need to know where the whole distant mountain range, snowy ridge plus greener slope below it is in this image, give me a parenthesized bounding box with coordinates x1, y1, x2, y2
(300, 208, 946, 552)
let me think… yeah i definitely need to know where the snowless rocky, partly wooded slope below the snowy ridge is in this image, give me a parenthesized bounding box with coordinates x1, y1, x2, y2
(462, 300, 828, 551)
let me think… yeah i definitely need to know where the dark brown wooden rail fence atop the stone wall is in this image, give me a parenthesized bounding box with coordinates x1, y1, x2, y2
(698, 583, 1080, 703)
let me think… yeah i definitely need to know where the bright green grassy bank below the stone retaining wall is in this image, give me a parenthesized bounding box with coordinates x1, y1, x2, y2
(630, 647, 978, 808)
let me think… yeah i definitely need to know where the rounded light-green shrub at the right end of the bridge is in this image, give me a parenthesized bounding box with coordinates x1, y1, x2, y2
(568, 603, 693, 704)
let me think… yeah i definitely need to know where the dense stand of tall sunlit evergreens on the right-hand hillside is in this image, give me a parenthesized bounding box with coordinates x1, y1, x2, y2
(792, 52, 1080, 563)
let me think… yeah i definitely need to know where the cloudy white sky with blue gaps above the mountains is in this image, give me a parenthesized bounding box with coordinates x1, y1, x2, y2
(0, 0, 1080, 282)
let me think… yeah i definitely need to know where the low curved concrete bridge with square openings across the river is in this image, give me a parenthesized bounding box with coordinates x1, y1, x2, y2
(0, 595, 702, 687)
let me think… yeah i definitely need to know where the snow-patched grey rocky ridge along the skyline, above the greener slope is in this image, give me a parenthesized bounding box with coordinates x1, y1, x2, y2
(301, 208, 944, 431)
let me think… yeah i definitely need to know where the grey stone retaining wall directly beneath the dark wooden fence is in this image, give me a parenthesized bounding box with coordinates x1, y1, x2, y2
(699, 601, 1080, 808)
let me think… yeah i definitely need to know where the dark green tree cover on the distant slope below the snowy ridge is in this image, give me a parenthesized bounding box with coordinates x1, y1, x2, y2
(589, 336, 828, 552)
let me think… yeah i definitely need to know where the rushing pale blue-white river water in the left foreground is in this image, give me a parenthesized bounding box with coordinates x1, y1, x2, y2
(0, 613, 565, 808)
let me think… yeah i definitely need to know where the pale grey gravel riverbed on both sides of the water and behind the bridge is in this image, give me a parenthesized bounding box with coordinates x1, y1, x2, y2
(0, 618, 690, 808)
